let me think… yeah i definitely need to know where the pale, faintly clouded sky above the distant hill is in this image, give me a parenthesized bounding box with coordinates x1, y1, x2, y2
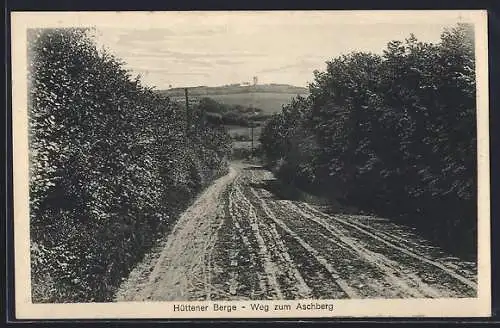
(91, 13, 464, 89)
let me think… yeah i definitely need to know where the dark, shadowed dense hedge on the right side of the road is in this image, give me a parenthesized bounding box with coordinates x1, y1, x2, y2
(261, 25, 476, 258)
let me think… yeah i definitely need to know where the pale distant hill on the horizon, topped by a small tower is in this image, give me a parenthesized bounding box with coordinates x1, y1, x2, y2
(157, 84, 309, 113)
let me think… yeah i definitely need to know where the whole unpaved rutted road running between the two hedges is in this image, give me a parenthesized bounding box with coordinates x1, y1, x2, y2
(116, 163, 477, 301)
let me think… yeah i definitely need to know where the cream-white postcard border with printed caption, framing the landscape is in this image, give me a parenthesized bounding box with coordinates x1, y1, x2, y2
(11, 10, 491, 319)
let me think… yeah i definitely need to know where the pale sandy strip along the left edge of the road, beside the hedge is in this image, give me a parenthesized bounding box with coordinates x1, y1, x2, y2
(115, 165, 239, 301)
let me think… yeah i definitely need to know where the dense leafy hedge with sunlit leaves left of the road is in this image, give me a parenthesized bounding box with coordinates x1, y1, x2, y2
(28, 29, 230, 302)
